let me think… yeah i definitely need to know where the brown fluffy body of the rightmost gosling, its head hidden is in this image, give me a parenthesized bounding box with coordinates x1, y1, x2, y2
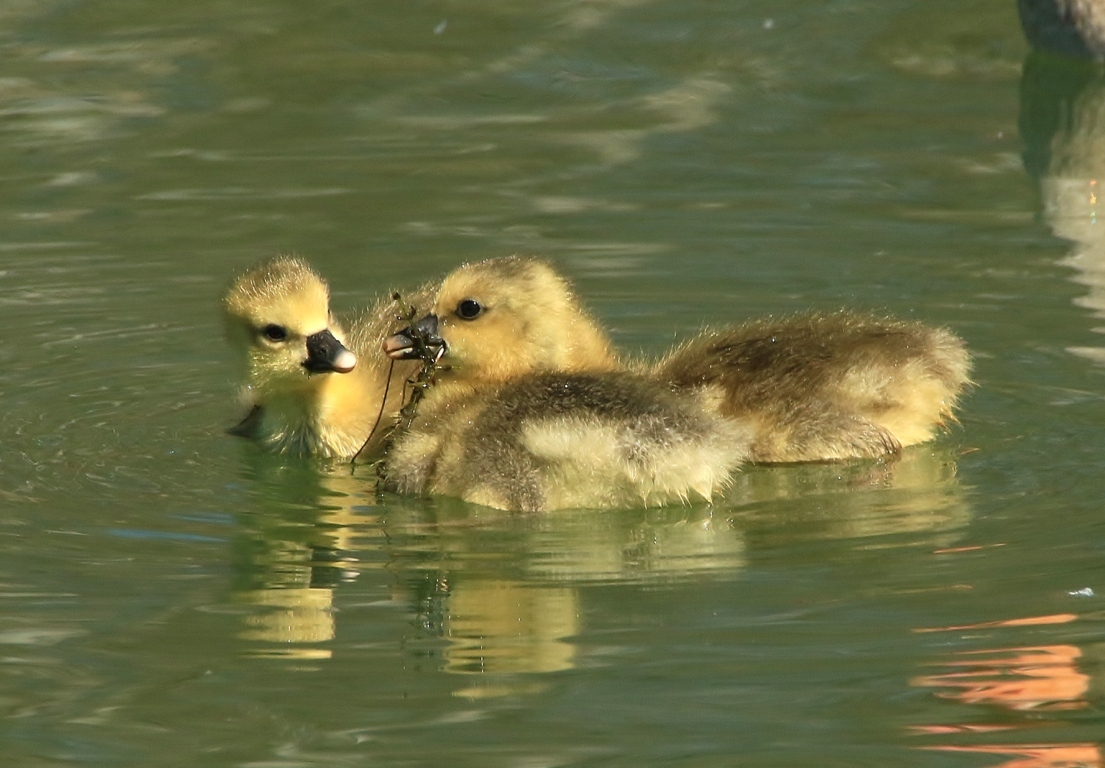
(655, 312, 970, 462)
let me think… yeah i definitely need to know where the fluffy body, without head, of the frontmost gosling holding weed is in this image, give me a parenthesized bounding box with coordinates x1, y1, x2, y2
(385, 372, 748, 512)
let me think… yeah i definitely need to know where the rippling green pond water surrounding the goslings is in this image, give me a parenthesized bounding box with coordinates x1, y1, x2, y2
(0, 0, 1105, 768)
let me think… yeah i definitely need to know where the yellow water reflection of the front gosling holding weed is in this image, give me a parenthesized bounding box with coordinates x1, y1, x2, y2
(381, 498, 744, 697)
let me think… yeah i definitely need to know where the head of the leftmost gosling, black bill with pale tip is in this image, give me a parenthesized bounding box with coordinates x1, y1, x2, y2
(222, 256, 357, 398)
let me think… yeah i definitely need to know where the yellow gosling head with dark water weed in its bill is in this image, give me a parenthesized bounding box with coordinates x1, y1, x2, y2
(383, 256, 614, 381)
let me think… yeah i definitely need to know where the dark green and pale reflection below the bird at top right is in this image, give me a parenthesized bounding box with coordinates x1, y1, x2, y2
(1020, 52, 1105, 362)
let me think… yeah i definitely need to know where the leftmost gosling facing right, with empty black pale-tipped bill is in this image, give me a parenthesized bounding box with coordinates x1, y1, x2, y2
(222, 256, 429, 456)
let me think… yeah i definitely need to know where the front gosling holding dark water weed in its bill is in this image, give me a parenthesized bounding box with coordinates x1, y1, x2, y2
(385, 257, 747, 511)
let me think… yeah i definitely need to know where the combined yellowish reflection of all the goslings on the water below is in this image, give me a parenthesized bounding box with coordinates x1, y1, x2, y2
(239, 448, 969, 698)
